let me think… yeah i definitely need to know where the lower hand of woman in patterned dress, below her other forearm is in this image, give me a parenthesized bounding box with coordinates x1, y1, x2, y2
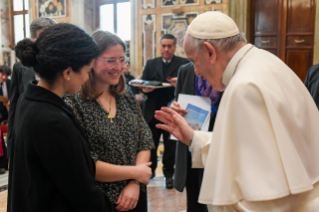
(115, 181, 140, 211)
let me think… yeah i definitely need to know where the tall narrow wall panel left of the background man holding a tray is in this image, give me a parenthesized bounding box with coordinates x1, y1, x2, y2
(142, 14, 156, 67)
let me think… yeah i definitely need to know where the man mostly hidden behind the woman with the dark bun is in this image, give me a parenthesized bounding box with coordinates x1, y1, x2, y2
(7, 17, 57, 157)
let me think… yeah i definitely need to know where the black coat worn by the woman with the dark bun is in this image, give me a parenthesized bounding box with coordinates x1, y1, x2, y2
(8, 84, 113, 212)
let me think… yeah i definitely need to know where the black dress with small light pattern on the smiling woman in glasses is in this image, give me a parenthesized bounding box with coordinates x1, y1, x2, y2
(64, 90, 154, 204)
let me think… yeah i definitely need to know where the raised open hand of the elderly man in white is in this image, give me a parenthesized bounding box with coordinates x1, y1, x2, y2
(155, 107, 194, 145)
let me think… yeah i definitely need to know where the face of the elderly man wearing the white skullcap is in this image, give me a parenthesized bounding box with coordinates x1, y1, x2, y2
(184, 35, 225, 91)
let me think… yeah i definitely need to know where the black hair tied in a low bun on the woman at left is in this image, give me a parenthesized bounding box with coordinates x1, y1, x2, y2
(15, 23, 99, 84)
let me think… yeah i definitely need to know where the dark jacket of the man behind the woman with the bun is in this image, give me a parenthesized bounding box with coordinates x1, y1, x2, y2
(7, 63, 35, 157)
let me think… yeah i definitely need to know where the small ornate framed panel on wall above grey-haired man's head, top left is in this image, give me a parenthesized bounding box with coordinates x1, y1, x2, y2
(37, 0, 66, 18)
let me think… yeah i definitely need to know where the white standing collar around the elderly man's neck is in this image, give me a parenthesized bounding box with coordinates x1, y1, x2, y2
(222, 44, 253, 87)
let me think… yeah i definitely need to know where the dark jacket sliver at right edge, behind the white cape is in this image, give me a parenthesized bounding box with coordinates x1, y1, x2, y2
(305, 64, 319, 109)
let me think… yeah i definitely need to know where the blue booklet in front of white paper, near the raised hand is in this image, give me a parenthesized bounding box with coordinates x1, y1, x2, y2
(184, 104, 209, 130)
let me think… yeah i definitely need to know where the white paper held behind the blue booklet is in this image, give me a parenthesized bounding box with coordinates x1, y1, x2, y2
(170, 94, 211, 140)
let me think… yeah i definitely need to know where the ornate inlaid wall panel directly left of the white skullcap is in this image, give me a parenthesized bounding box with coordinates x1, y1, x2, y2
(161, 12, 198, 57)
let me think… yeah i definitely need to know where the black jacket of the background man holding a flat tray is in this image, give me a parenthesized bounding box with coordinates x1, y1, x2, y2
(142, 56, 189, 123)
